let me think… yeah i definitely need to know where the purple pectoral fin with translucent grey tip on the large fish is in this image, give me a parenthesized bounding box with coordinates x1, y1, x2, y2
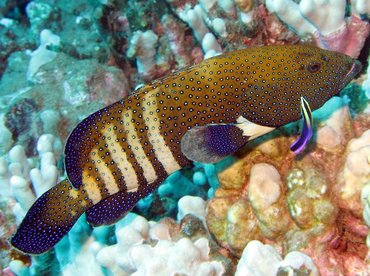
(181, 124, 249, 163)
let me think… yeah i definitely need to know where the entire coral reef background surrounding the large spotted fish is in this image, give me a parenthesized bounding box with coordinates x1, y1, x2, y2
(0, 0, 370, 275)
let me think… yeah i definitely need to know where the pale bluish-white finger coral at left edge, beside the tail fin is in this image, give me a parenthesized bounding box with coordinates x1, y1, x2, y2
(0, 134, 62, 272)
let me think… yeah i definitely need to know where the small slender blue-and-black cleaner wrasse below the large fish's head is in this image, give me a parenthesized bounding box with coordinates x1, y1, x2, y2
(290, 97, 312, 154)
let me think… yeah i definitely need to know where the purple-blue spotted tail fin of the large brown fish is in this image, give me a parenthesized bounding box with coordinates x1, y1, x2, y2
(10, 180, 92, 254)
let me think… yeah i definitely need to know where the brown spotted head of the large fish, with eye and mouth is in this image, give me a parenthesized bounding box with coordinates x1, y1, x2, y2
(243, 45, 361, 127)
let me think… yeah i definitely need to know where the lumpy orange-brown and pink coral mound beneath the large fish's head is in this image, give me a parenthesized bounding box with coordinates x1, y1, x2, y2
(206, 98, 370, 275)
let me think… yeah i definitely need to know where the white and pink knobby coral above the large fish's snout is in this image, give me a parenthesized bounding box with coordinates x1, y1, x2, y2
(266, 0, 370, 57)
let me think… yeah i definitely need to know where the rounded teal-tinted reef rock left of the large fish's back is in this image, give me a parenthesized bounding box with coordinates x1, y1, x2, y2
(0, 50, 128, 146)
